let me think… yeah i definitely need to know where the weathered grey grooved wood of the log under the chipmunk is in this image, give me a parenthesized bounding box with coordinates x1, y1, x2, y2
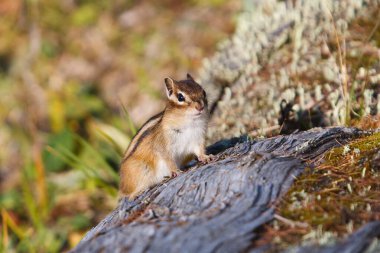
(72, 127, 380, 252)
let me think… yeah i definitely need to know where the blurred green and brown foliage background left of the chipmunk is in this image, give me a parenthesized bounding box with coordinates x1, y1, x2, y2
(0, 0, 241, 252)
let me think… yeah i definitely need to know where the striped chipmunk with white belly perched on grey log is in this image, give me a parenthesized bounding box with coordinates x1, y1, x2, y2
(120, 74, 211, 200)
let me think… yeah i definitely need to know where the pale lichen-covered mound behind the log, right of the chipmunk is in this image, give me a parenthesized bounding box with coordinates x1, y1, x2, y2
(200, 0, 380, 142)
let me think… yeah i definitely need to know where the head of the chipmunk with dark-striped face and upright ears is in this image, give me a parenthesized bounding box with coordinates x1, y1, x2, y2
(165, 74, 208, 117)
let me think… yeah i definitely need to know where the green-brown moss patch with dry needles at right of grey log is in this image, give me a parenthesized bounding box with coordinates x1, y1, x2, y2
(268, 133, 380, 247)
